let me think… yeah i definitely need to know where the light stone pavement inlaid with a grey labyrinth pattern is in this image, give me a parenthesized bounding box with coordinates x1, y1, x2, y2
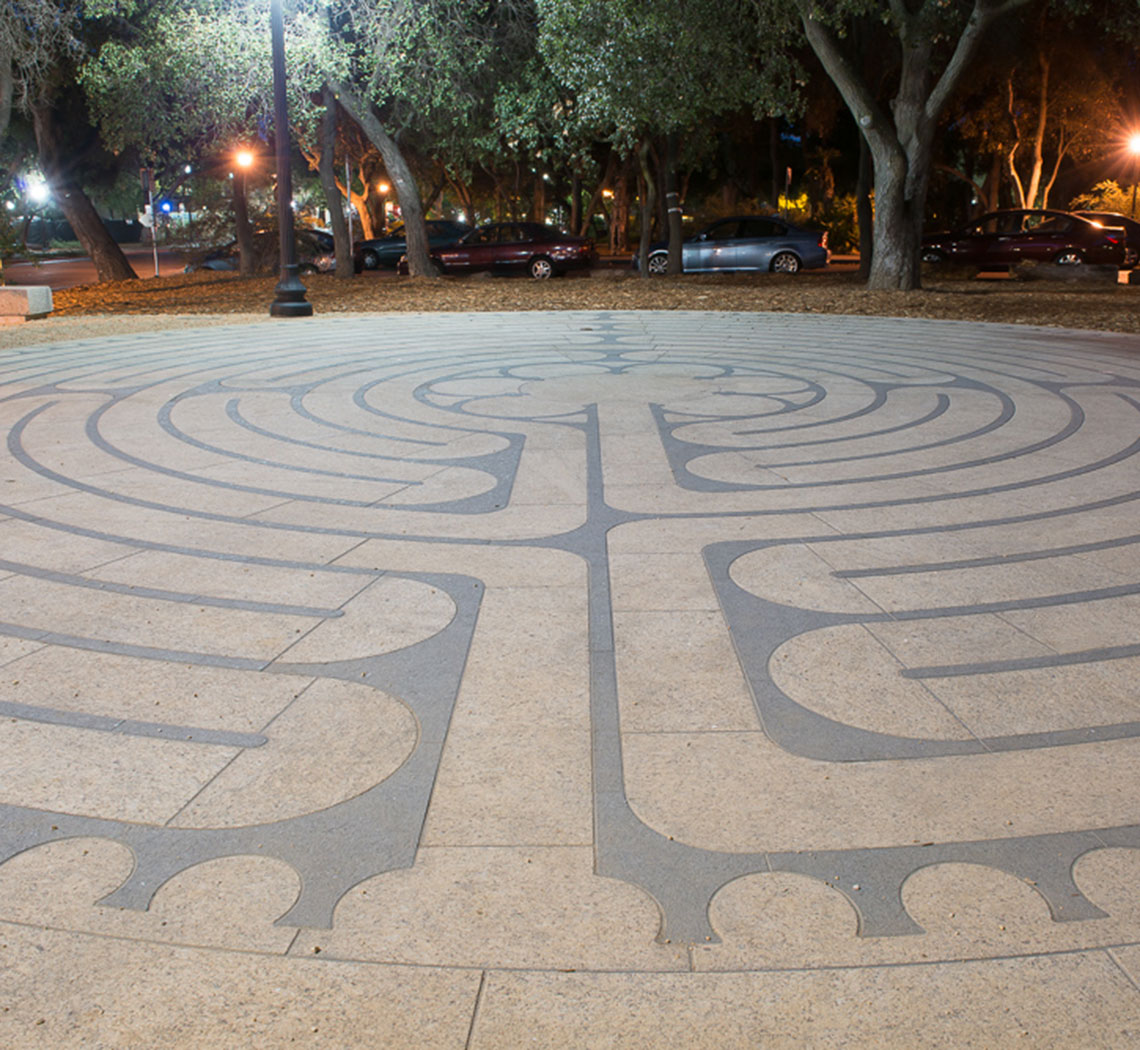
(0, 314, 1140, 1050)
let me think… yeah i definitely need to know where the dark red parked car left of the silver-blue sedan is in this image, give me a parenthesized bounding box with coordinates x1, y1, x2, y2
(401, 222, 597, 279)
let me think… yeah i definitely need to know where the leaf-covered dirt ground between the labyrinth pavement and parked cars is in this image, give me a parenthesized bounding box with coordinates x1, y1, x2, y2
(0, 268, 1140, 347)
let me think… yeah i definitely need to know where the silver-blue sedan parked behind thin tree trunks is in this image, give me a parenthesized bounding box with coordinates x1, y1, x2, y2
(634, 215, 831, 274)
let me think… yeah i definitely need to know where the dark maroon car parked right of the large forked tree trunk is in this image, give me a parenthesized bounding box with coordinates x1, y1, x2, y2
(922, 209, 1124, 266)
